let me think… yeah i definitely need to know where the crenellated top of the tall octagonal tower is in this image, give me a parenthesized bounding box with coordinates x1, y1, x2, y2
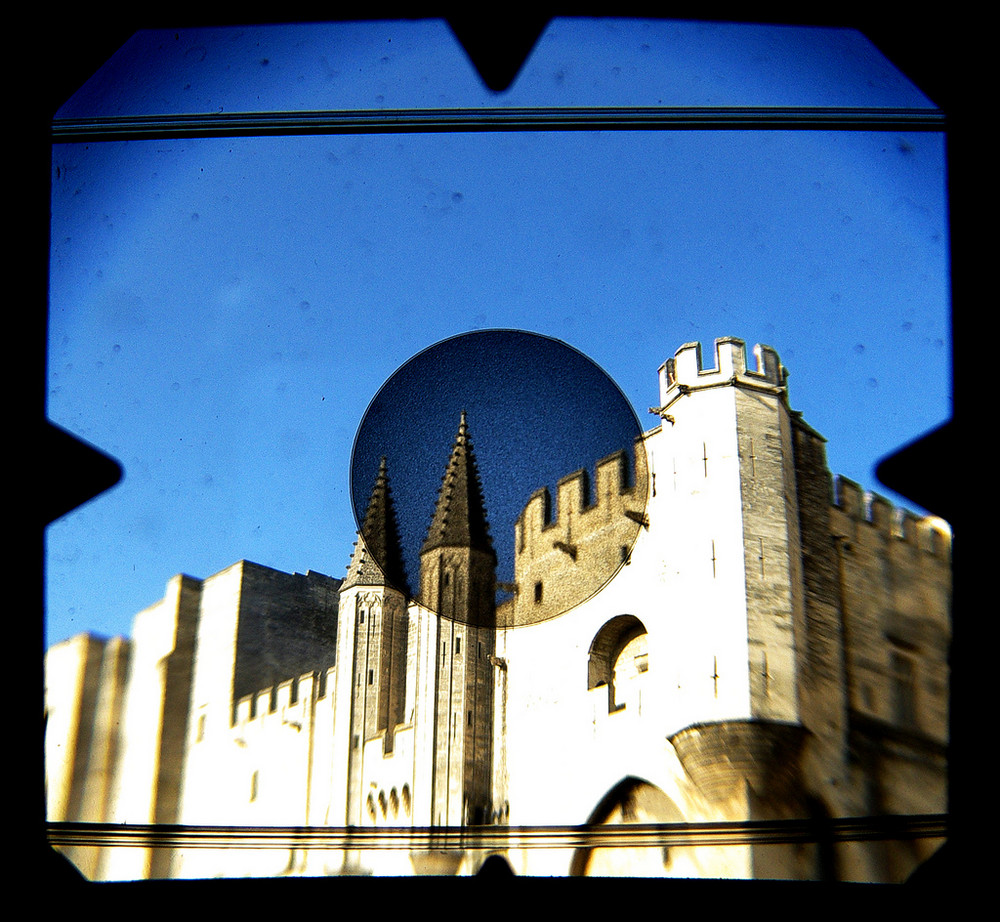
(652, 336, 788, 412)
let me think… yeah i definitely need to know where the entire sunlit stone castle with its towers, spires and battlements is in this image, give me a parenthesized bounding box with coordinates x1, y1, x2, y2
(46, 339, 951, 881)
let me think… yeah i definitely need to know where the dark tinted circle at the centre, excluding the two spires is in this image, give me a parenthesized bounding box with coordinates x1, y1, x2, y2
(351, 330, 646, 623)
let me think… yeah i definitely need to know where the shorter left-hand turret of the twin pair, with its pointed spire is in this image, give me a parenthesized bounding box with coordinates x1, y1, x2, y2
(334, 458, 409, 825)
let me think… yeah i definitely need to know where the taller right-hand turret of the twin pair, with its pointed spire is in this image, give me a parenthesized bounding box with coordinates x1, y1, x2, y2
(420, 411, 497, 825)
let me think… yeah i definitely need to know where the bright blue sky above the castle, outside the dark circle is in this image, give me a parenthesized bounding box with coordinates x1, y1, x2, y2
(46, 20, 951, 643)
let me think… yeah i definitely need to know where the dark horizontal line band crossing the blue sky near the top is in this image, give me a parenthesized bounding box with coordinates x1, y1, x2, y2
(52, 106, 945, 143)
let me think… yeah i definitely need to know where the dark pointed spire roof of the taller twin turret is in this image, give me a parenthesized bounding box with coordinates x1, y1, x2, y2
(420, 410, 496, 557)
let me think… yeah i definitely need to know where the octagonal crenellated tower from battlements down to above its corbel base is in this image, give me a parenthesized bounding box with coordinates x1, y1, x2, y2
(652, 338, 812, 722)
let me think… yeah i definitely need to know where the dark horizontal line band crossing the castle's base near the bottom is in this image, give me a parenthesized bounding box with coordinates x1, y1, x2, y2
(46, 814, 948, 850)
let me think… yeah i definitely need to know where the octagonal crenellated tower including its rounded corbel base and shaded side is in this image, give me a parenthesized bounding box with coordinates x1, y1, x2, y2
(651, 338, 828, 856)
